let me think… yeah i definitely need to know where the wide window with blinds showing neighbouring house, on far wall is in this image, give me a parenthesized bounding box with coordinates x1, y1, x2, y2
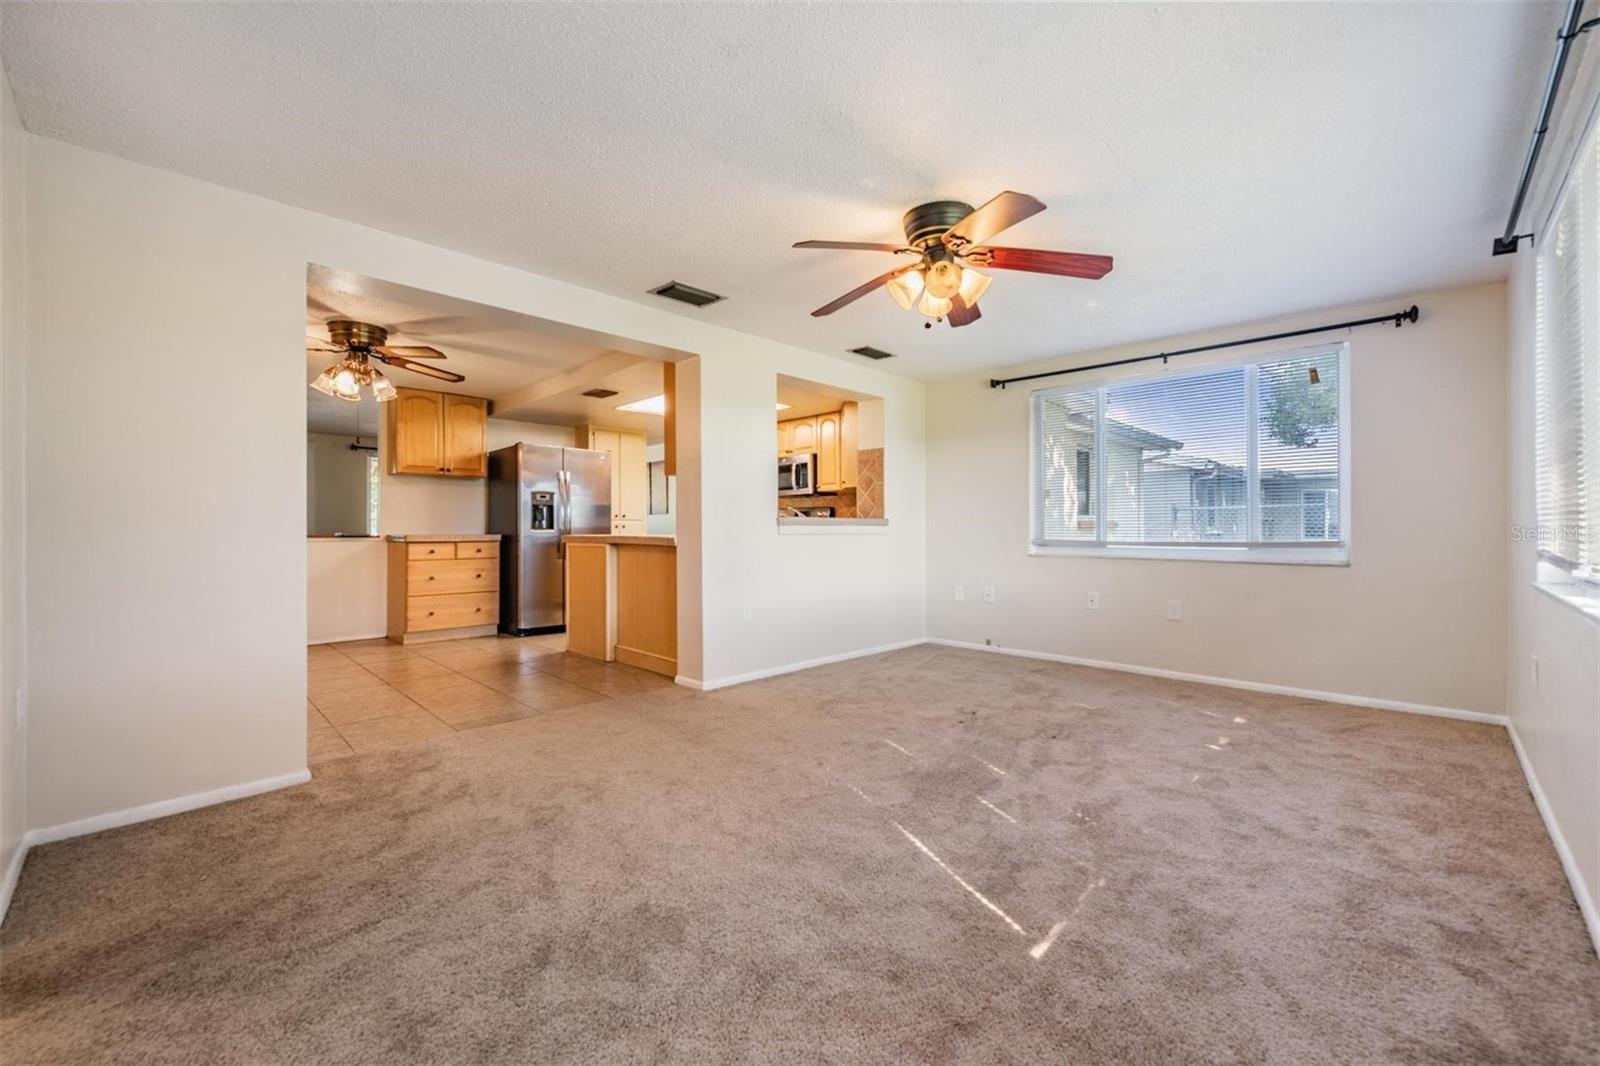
(1032, 344, 1349, 562)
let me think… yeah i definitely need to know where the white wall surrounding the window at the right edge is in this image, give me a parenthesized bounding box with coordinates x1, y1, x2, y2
(1506, 48, 1600, 949)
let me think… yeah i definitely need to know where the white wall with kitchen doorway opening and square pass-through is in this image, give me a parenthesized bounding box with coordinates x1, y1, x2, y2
(27, 138, 923, 826)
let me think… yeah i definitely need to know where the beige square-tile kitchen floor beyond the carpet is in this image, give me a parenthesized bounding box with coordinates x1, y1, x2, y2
(306, 634, 672, 765)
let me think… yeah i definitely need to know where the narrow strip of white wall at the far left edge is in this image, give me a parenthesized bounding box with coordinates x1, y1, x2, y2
(0, 62, 29, 917)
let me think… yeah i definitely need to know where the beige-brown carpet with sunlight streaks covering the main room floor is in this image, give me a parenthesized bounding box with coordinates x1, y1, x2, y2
(0, 647, 1600, 1064)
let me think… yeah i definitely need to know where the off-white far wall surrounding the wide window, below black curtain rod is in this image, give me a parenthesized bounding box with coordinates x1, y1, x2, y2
(921, 285, 1506, 714)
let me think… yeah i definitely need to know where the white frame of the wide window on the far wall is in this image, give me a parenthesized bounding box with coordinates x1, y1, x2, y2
(1027, 341, 1352, 567)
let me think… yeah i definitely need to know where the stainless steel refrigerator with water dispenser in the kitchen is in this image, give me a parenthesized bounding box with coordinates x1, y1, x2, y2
(490, 443, 611, 635)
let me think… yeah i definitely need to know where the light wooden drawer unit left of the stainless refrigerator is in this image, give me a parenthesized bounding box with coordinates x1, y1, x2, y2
(389, 541, 499, 643)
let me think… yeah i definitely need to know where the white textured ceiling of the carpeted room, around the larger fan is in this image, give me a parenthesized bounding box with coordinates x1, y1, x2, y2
(0, 3, 1562, 378)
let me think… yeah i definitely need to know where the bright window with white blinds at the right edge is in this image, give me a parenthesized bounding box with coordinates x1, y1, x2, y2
(1534, 108, 1600, 583)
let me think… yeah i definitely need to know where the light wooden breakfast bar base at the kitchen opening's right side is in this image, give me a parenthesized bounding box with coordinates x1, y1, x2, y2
(562, 533, 678, 677)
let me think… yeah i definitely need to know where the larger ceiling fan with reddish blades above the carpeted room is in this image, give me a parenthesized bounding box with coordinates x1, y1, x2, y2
(795, 192, 1110, 330)
